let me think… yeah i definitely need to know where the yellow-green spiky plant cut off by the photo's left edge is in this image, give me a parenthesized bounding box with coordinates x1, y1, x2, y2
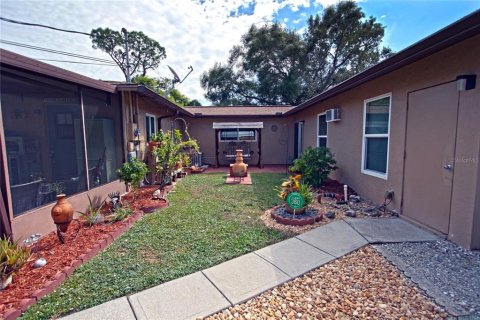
(0, 238, 30, 281)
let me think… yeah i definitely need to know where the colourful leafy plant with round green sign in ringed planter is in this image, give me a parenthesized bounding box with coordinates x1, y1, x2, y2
(277, 175, 314, 214)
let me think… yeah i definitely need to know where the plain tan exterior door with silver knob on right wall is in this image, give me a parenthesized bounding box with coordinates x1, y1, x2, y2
(402, 82, 458, 234)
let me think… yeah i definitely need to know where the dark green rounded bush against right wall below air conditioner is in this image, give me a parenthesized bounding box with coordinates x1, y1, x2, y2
(290, 147, 337, 187)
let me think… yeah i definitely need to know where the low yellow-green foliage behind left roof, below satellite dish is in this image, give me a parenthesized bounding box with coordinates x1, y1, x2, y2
(132, 76, 202, 107)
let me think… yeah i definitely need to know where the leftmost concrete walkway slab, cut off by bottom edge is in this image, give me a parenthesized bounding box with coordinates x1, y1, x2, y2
(61, 297, 135, 320)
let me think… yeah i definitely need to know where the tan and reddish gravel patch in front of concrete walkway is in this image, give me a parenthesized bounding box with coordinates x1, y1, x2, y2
(208, 247, 449, 320)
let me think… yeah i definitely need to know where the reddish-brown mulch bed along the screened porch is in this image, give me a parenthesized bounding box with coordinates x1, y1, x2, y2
(0, 186, 171, 319)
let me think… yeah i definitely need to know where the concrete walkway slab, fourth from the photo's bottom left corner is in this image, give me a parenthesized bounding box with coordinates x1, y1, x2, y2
(255, 238, 335, 278)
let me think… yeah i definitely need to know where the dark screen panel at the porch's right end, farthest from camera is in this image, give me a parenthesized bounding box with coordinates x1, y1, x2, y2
(82, 89, 122, 188)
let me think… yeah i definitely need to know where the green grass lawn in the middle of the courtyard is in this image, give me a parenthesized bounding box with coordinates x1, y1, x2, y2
(22, 173, 288, 319)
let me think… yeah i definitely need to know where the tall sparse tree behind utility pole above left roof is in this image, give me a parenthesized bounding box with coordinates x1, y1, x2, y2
(90, 28, 167, 78)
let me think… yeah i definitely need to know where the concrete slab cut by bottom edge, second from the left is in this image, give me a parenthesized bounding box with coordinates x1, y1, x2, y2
(129, 272, 230, 320)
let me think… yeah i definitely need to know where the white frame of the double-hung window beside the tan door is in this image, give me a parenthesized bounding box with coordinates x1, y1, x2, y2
(361, 92, 392, 180)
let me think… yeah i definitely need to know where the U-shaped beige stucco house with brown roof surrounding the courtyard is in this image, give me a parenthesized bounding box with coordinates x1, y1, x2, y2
(0, 12, 480, 249)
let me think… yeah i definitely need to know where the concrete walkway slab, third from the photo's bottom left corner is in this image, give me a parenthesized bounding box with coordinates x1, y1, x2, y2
(203, 253, 291, 304)
